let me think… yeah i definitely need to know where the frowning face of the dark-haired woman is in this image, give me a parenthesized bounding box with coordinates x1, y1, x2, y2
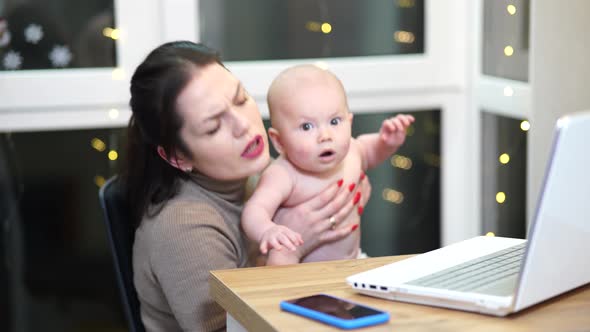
(176, 63, 270, 180)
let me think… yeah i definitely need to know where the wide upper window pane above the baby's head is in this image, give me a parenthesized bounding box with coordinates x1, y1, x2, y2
(199, 0, 424, 61)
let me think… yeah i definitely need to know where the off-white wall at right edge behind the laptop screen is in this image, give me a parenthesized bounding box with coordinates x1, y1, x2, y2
(527, 0, 590, 220)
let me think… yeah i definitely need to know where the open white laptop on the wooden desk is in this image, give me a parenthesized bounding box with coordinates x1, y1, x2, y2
(346, 112, 590, 316)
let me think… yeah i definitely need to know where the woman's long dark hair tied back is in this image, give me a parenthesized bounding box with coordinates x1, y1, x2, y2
(123, 41, 221, 227)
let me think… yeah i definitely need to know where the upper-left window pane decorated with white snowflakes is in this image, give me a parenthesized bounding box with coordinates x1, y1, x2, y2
(0, 0, 118, 70)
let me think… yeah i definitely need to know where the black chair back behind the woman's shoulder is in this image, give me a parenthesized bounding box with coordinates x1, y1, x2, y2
(98, 176, 145, 332)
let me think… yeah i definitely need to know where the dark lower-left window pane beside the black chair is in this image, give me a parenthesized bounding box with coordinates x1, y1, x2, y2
(0, 129, 126, 331)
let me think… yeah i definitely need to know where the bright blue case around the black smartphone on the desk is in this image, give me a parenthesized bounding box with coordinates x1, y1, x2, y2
(281, 294, 389, 329)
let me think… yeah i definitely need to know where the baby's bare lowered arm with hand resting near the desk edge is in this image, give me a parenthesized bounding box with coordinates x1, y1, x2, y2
(242, 164, 303, 254)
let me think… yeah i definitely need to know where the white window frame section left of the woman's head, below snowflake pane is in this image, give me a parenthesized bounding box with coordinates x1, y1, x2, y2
(0, 0, 161, 132)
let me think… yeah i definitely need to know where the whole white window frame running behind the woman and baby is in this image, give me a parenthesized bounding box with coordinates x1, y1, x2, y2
(0, 0, 481, 245)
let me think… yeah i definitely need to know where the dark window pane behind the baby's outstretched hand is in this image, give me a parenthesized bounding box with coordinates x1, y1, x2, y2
(353, 110, 441, 256)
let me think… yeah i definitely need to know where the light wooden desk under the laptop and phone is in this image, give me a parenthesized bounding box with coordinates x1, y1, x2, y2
(209, 256, 590, 332)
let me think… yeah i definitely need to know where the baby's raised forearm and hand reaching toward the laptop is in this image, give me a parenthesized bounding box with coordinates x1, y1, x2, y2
(357, 114, 414, 170)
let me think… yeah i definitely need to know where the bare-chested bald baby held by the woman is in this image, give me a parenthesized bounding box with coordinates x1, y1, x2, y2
(242, 65, 414, 265)
